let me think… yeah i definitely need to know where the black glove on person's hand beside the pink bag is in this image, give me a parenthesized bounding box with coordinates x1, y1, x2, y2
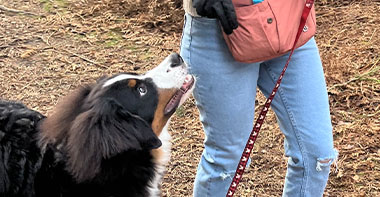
(193, 0, 238, 34)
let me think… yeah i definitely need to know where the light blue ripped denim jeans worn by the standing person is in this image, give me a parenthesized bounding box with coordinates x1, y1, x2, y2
(181, 14, 337, 197)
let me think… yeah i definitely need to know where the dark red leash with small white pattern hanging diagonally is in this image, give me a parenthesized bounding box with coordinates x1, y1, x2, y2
(226, 0, 314, 197)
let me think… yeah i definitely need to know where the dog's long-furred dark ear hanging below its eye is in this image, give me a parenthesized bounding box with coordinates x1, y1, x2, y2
(67, 98, 161, 182)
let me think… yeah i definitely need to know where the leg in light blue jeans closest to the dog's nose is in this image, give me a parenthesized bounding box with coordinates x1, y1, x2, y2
(181, 15, 259, 197)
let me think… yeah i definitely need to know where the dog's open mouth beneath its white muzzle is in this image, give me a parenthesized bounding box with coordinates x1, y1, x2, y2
(165, 75, 195, 115)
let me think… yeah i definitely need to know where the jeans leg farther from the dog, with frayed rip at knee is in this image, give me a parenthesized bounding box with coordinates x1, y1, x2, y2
(258, 38, 337, 197)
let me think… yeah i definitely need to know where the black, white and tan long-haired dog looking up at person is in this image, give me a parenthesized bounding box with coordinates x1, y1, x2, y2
(0, 53, 195, 197)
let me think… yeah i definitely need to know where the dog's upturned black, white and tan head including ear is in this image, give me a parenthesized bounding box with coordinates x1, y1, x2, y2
(41, 54, 195, 181)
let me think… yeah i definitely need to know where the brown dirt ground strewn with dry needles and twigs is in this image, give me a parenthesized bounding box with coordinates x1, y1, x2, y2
(0, 0, 380, 196)
